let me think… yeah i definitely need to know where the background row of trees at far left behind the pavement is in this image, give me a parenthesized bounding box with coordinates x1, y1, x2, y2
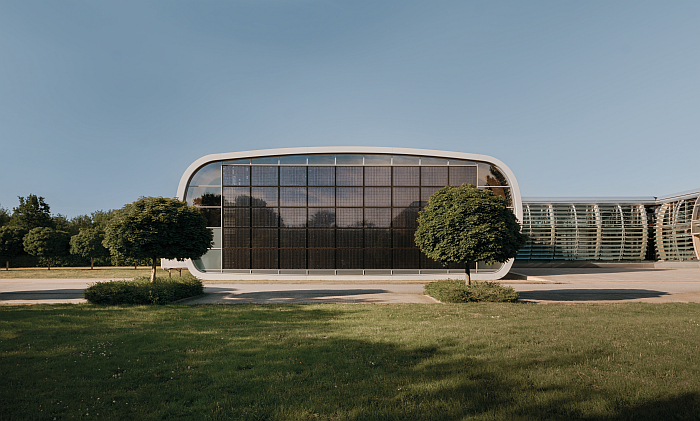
(0, 194, 149, 268)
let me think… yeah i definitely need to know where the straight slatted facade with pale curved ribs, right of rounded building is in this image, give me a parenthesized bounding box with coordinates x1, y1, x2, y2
(517, 203, 648, 260)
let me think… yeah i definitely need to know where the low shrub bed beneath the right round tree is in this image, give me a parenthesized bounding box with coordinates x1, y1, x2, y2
(425, 280, 518, 303)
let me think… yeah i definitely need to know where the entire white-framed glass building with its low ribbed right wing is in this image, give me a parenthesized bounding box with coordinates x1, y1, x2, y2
(171, 147, 700, 280)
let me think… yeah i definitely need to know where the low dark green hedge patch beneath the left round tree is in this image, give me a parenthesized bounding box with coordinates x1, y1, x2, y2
(85, 275, 204, 305)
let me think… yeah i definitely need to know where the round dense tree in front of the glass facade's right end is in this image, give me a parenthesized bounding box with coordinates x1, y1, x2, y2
(415, 184, 527, 284)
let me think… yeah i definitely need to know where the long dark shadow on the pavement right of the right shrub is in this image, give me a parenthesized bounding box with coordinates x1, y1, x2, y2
(519, 288, 669, 301)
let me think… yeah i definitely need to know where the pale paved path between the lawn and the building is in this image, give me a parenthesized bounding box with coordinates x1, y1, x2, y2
(0, 268, 700, 304)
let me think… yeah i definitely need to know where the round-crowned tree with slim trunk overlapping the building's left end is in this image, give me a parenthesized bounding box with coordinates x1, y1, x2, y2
(103, 197, 213, 282)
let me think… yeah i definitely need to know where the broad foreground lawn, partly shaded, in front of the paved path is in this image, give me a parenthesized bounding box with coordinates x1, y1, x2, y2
(0, 303, 700, 420)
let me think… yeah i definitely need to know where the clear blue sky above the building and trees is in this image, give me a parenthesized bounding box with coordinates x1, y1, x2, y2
(0, 0, 700, 218)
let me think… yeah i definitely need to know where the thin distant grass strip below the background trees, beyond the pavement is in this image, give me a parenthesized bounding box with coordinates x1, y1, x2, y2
(0, 266, 189, 279)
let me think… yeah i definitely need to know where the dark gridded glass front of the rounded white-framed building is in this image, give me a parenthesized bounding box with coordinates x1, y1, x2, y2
(186, 154, 512, 272)
